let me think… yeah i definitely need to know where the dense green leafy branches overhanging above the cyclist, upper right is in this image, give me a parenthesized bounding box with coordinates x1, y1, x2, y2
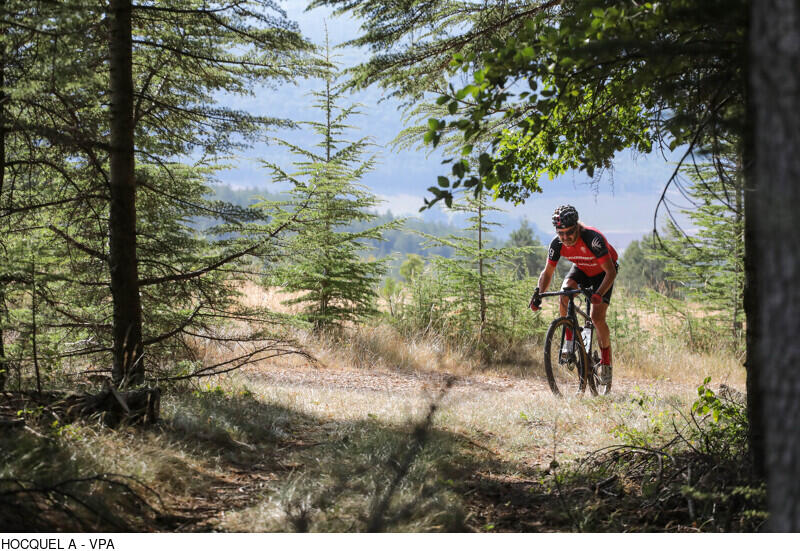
(424, 0, 747, 204)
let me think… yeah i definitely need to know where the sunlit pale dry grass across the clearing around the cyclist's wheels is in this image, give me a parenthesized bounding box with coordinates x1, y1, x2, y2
(198, 282, 744, 529)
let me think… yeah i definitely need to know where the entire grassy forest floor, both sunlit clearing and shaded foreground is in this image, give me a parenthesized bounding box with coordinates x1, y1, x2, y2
(0, 286, 758, 532)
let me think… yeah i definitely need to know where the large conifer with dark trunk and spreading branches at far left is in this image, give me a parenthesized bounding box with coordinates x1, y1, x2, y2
(0, 0, 314, 388)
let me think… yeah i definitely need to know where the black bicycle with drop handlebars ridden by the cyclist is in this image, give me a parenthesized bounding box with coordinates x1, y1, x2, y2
(531, 287, 612, 396)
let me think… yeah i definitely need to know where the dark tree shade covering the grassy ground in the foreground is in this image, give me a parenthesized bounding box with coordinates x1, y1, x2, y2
(0, 383, 763, 532)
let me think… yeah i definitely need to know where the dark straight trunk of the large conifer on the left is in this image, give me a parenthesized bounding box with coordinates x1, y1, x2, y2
(109, 0, 144, 386)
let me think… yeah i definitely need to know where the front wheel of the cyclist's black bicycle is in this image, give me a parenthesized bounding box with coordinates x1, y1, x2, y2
(544, 317, 589, 396)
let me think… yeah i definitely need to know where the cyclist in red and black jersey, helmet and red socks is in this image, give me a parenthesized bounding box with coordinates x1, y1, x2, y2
(531, 205, 619, 384)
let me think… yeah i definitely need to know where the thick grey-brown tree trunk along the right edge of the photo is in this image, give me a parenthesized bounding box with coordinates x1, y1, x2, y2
(745, 0, 800, 532)
